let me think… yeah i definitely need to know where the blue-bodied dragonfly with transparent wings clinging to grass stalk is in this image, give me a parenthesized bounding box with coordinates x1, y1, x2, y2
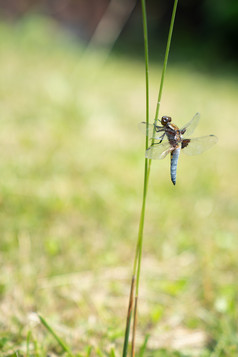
(141, 113, 218, 185)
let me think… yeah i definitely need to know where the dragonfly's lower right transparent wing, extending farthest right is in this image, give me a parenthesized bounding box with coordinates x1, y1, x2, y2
(182, 135, 218, 155)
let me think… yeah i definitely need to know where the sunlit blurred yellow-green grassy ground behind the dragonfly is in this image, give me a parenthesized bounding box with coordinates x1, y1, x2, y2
(0, 15, 238, 357)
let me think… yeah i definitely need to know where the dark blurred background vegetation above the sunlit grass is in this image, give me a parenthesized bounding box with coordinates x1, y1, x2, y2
(0, 0, 238, 64)
